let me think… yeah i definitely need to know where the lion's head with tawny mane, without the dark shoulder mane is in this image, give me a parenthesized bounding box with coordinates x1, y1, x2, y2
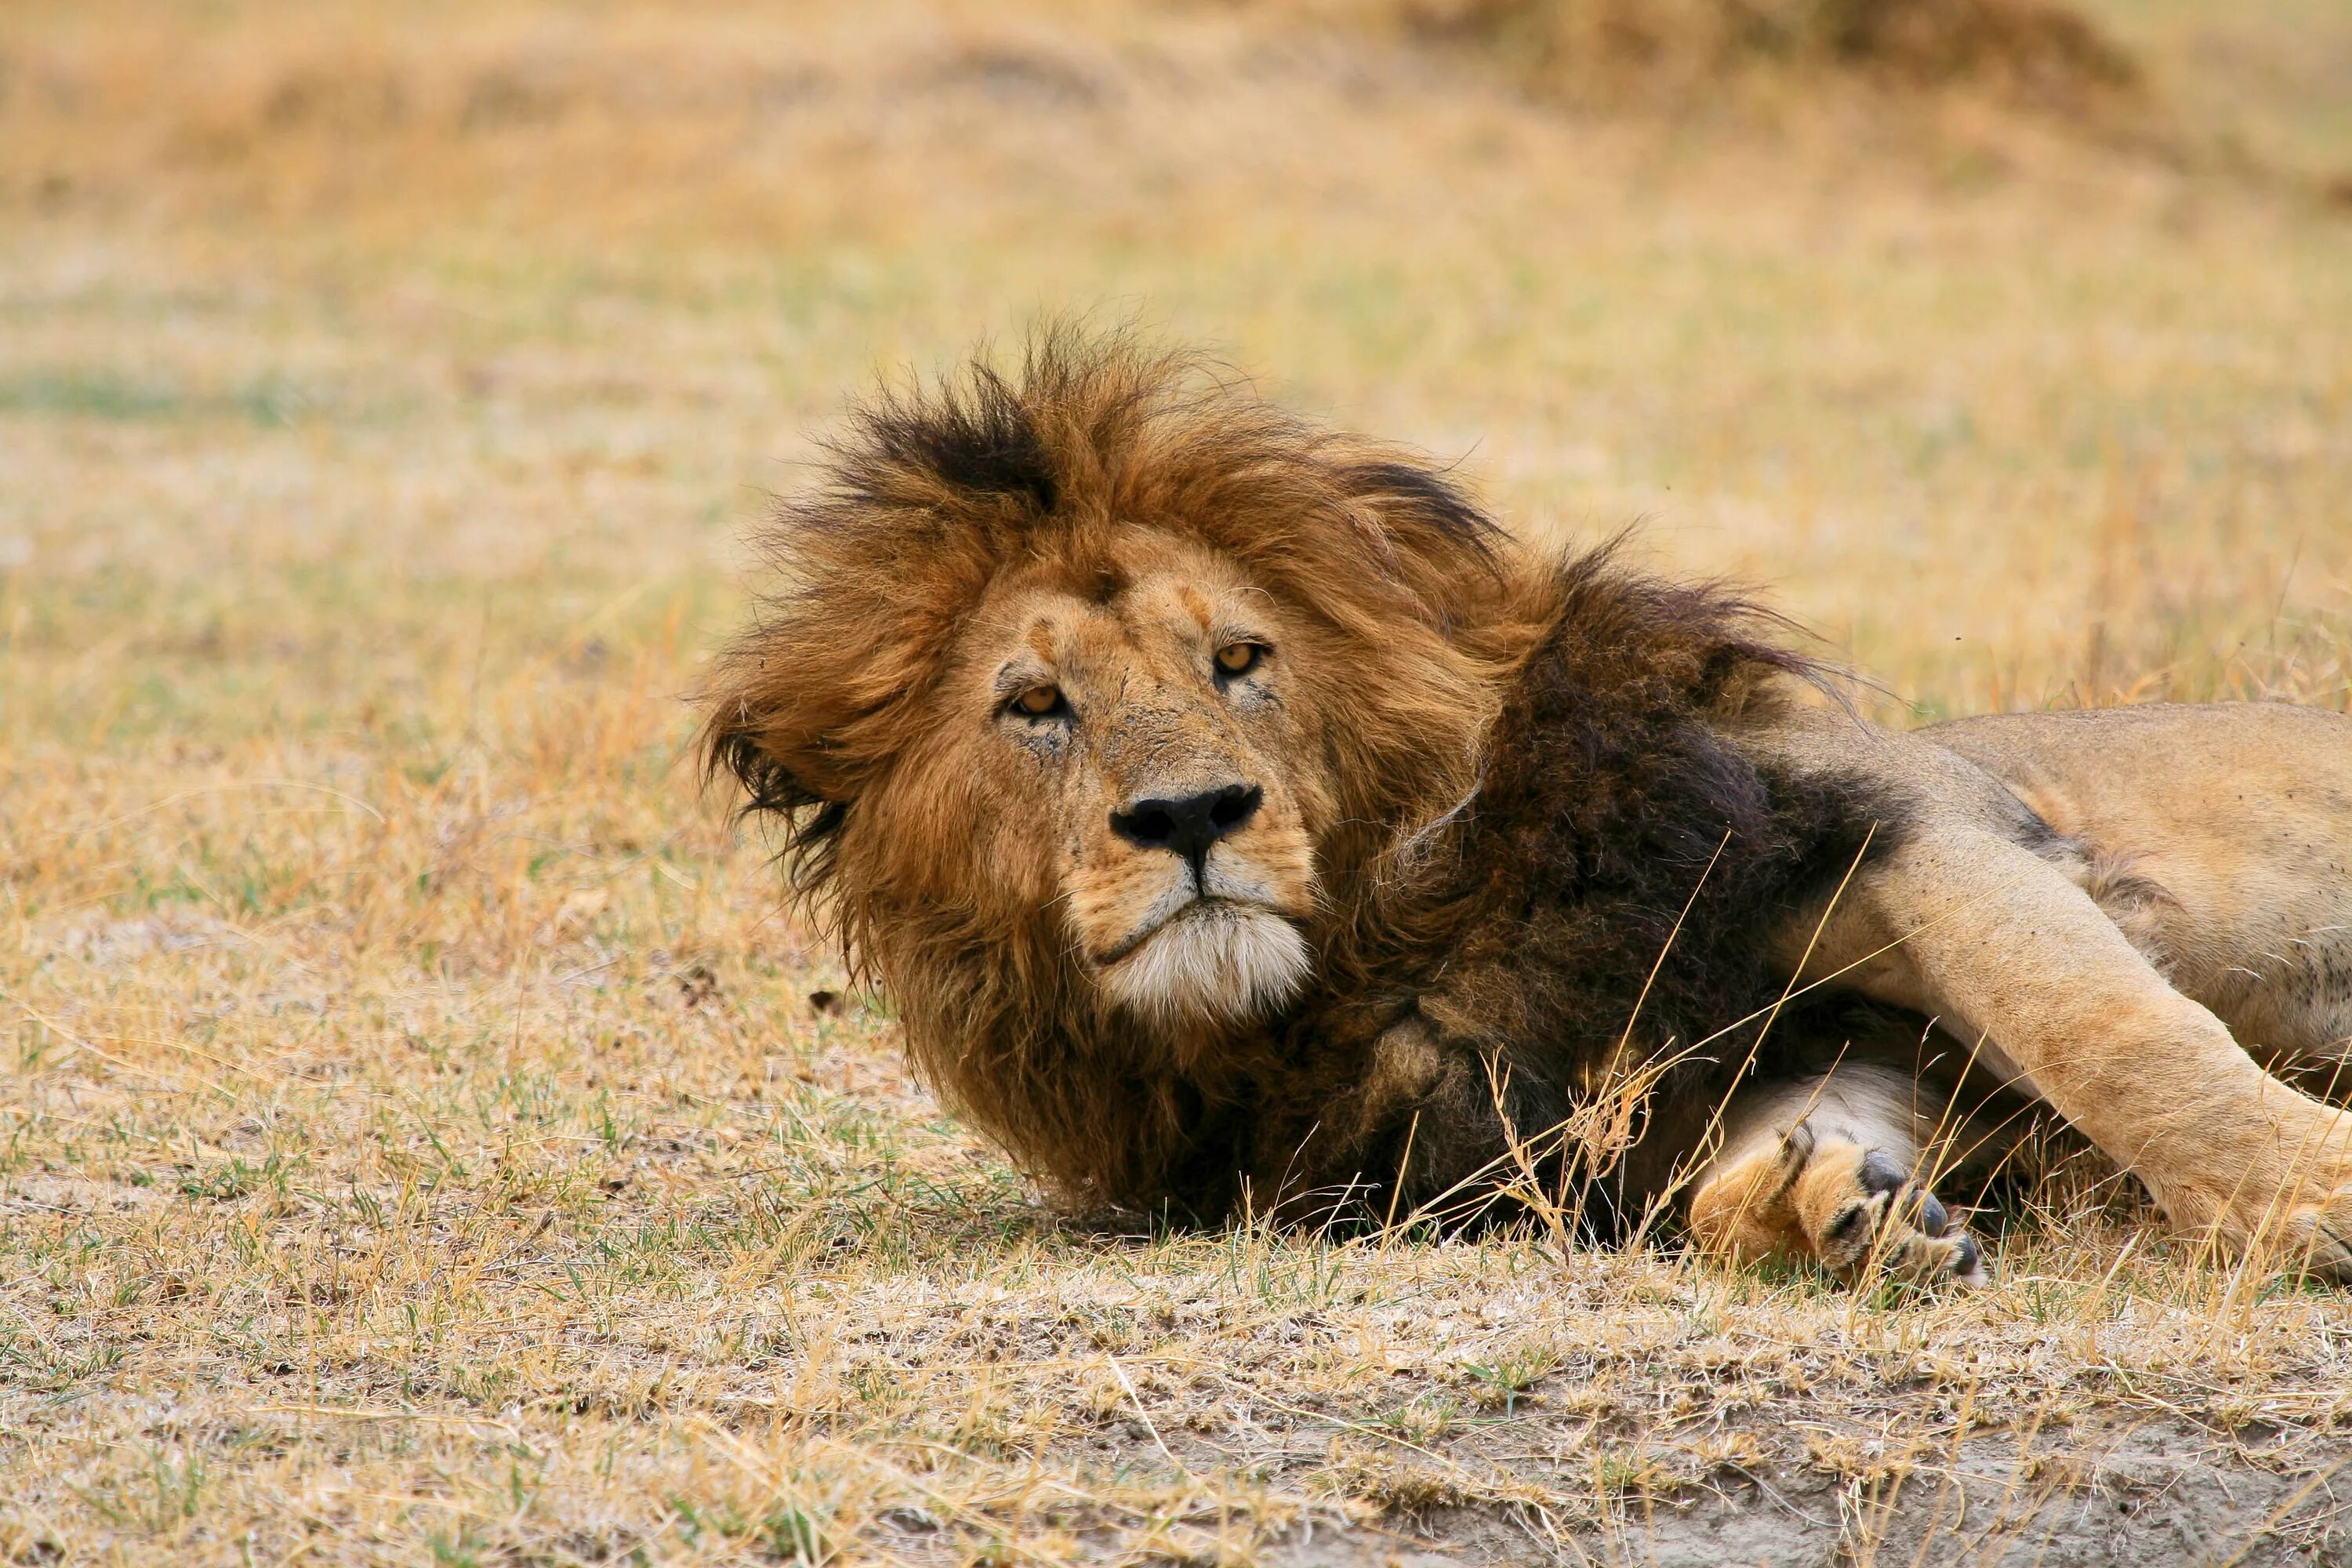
(706, 332, 1538, 1189)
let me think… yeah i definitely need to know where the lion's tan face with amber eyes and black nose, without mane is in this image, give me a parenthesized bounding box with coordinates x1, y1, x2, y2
(938, 529, 1331, 1029)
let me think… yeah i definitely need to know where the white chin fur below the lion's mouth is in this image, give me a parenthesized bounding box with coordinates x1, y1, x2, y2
(1101, 902, 1315, 1027)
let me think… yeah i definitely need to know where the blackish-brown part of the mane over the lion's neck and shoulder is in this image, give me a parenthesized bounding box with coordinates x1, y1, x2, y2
(1251, 557, 1903, 1229)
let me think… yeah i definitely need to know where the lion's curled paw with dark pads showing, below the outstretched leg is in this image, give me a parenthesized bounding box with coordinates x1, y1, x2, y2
(1691, 1062, 1985, 1286)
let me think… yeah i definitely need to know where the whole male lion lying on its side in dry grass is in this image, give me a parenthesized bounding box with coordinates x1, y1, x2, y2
(706, 332, 2352, 1281)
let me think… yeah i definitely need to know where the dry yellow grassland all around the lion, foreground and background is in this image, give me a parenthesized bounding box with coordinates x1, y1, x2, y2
(0, 0, 2352, 1563)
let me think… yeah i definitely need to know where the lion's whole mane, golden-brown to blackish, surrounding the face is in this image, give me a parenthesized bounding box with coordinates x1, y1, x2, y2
(706, 329, 1896, 1218)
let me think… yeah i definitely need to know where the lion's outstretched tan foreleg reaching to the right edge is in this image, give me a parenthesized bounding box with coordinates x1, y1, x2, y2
(1809, 829, 2352, 1279)
